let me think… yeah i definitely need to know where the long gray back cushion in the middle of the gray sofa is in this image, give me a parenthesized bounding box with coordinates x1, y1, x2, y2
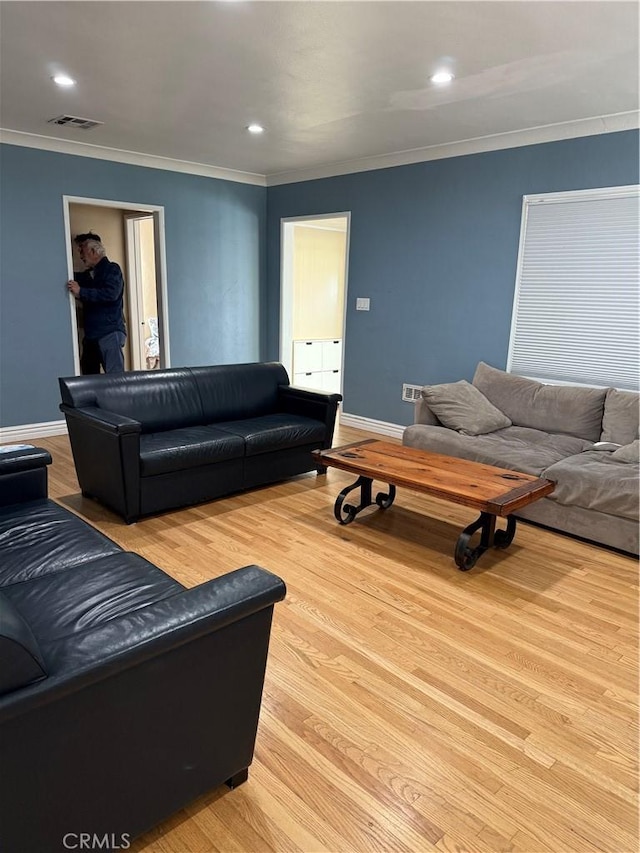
(473, 361, 607, 441)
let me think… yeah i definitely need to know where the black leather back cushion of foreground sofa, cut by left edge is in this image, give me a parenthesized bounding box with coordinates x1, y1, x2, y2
(0, 592, 47, 695)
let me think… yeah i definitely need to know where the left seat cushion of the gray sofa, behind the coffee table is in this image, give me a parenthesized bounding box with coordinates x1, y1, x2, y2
(402, 424, 590, 477)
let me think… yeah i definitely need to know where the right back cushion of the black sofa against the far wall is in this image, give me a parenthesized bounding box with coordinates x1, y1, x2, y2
(191, 362, 289, 424)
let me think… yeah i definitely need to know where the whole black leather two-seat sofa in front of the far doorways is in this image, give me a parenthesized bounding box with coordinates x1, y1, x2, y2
(59, 362, 342, 523)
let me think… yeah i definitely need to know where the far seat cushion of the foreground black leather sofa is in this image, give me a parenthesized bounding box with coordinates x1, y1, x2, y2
(0, 500, 121, 587)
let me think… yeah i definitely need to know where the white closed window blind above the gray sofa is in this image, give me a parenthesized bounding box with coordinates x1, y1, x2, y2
(507, 186, 640, 390)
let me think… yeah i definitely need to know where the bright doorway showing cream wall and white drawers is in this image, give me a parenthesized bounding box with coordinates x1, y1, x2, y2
(280, 213, 350, 393)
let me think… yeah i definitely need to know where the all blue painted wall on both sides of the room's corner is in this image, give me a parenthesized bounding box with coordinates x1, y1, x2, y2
(0, 131, 639, 427)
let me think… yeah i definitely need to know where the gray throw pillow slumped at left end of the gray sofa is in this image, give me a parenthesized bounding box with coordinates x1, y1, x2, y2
(422, 379, 511, 435)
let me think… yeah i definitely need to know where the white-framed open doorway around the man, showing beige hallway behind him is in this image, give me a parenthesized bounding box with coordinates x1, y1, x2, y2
(63, 196, 170, 375)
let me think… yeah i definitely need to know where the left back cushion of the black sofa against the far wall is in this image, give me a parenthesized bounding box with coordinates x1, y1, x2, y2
(61, 368, 206, 433)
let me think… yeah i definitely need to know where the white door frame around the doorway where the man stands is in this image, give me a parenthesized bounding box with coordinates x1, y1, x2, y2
(62, 200, 171, 376)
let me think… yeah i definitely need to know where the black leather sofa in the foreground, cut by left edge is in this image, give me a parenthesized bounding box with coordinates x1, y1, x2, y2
(0, 448, 285, 853)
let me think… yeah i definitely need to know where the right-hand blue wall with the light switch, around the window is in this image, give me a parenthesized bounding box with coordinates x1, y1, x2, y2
(267, 131, 639, 424)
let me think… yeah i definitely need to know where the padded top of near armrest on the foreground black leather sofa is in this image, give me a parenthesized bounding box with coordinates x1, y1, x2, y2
(0, 566, 286, 722)
